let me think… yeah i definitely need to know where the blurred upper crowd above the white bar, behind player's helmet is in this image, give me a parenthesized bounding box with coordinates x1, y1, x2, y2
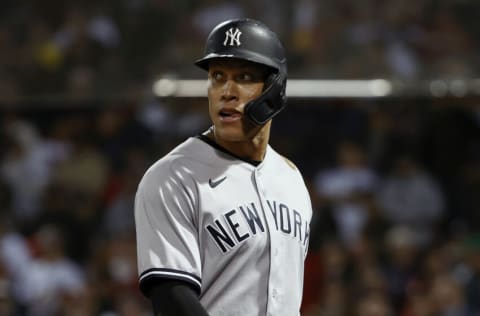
(0, 0, 480, 102)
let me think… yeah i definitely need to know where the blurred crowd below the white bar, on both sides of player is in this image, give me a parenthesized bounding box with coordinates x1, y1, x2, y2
(0, 99, 480, 316)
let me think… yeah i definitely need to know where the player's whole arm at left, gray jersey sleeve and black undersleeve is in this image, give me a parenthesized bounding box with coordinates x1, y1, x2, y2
(135, 164, 208, 316)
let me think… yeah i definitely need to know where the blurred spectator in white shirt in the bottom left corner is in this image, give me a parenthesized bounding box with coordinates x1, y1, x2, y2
(0, 225, 86, 316)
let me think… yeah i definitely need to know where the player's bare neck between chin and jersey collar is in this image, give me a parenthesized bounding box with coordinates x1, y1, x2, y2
(207, 122, 271, 161)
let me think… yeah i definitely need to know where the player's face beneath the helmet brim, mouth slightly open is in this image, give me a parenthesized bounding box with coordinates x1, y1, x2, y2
(208, 59, 267, 142)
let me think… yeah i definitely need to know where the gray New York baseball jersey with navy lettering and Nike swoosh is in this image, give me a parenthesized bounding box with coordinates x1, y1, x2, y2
(135, 132, 312, 316)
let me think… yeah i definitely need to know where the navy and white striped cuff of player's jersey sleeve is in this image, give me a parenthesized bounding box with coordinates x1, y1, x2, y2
(139, 268, 202, 294)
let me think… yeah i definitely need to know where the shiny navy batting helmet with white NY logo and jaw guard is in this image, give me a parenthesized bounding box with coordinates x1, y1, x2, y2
(195, 18, 287, 125)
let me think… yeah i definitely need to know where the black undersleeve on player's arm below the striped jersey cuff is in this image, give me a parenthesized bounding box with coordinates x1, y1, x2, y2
(149, 280, 208, 316)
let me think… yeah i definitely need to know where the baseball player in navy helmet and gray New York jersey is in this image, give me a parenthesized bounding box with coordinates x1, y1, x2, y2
(135, 19, 312, 316)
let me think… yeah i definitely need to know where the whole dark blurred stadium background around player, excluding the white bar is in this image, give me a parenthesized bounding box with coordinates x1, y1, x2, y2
(0, 0, 480, 316)
